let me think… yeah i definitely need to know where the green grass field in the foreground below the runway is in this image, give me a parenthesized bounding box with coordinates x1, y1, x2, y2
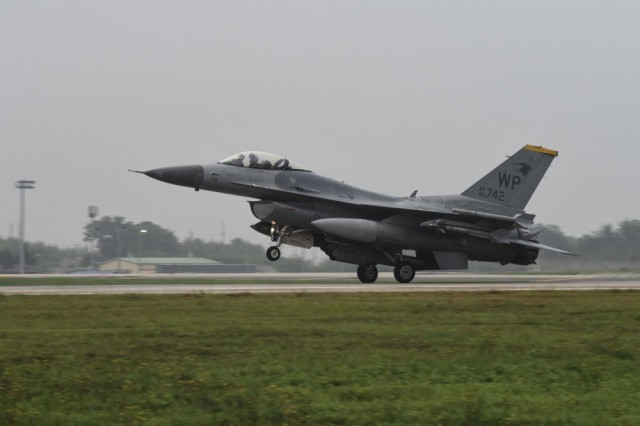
(0, 292, 640, 425)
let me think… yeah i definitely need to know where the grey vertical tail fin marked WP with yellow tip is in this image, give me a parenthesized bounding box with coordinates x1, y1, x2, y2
(462, 145, 558, 210)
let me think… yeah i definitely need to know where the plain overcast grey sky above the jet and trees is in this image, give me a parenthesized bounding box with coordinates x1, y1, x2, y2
(0, 0, 640, 246)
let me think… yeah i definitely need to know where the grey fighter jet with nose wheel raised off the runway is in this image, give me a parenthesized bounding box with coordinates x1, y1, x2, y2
(139, 145, 573, 283)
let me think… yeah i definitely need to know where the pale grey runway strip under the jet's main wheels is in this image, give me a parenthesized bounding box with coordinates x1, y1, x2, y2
(0, 273, 640, 295)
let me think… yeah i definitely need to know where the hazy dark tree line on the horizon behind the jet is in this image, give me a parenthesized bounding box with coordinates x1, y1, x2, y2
(0, 216, 640, 272)
